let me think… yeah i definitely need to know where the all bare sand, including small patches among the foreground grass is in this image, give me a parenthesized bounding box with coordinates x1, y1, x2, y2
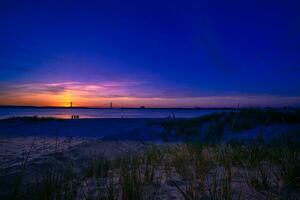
(0, 119, 300, 199)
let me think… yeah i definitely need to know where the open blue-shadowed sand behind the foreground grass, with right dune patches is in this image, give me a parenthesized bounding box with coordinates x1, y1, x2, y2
(0, 119, 300, 171)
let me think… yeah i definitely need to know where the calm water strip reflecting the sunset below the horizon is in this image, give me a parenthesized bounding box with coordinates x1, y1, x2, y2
(0, 108, 226, 119)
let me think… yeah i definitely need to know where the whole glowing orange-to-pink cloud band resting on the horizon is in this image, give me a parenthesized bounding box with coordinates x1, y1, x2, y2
(0, 81, 300, 107)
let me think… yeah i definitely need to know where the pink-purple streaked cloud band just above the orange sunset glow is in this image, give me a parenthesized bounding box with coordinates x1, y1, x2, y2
(0, 80, 205, 98)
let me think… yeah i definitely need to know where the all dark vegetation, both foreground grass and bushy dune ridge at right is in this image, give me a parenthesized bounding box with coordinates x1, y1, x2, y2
(0, 109, 300, 200)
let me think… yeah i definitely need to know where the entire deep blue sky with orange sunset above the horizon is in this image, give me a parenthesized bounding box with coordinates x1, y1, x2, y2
(0, 0, 300, 107)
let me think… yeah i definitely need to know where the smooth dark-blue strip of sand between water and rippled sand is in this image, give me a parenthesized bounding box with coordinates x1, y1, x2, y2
(0, 118, 162, 139)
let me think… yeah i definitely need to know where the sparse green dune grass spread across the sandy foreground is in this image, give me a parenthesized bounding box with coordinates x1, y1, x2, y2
(1, 138, 300, 200)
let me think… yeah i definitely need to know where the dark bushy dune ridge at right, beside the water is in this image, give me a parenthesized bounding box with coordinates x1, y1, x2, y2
(160, 108, 300, 142)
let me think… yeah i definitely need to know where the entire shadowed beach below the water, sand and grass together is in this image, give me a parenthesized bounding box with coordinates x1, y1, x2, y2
(0, 110, 300, 199)
